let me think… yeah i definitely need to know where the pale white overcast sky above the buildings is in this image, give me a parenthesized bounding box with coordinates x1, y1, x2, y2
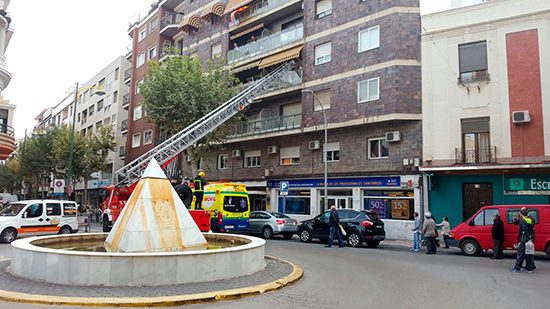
(2, 0, 449, 138)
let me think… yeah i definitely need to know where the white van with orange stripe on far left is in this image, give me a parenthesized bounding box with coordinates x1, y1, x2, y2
(0, 200, 78, 243)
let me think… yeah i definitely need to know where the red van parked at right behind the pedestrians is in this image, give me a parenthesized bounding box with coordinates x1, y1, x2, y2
(451, 205, 550, 256)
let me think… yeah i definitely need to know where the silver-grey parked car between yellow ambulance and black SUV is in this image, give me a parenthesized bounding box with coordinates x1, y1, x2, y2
(248, 211, 298, 239)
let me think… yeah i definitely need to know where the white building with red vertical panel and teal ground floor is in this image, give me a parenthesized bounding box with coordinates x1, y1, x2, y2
(421, 0, 550, 225)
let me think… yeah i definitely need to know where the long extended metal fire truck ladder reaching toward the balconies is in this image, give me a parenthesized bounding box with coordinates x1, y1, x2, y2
(116, 61, 295, 186)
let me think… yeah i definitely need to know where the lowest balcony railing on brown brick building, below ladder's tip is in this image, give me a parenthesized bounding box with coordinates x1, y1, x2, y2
(230, 114, 302, 137)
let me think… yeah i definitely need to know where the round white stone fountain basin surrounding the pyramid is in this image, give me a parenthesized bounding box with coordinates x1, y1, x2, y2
(9, 233, 265, 286)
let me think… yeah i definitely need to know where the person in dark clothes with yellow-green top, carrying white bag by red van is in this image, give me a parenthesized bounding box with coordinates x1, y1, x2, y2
(512, 207, 537, 272)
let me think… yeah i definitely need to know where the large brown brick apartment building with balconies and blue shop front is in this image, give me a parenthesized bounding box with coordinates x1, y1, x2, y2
(129, 0, 422, 238)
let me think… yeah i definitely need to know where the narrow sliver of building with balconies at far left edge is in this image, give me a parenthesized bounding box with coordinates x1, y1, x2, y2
(0, 1, 15, 160)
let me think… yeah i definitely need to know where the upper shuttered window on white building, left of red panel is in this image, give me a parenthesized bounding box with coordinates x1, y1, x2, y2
(458, 41, 489, 82)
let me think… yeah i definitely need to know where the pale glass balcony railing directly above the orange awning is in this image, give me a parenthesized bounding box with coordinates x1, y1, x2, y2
(227, 25, 304, 63)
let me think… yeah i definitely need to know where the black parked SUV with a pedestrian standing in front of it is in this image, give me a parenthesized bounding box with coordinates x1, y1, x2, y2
(298, 209, 386, 247)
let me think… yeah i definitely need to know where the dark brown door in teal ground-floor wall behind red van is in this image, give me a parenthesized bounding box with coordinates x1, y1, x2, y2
(462, 183, 493, 220)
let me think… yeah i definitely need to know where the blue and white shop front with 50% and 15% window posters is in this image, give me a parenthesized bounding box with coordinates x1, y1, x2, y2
(267, 175, 421, 239)
